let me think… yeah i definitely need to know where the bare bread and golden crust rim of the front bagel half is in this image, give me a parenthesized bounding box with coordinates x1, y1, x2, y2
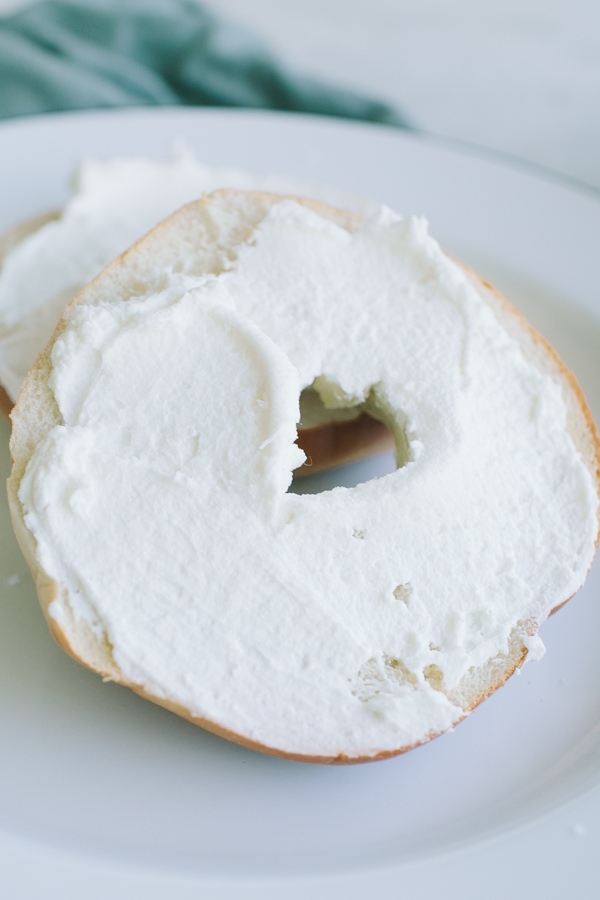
(8, 191, 600, 764)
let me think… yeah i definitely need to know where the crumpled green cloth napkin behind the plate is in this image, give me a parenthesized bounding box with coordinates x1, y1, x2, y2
(0, 0, 407, 127)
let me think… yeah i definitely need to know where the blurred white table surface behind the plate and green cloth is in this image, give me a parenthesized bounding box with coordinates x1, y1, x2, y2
(0, 0, 600, 188)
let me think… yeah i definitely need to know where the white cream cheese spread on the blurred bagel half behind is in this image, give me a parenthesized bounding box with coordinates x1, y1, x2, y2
(0, 152, 370, 401)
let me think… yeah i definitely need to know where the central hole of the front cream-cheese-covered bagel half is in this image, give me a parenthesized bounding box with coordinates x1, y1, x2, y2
(289, 379, 409, 494)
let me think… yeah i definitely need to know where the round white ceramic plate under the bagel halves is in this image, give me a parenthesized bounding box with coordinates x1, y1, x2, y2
(0, 109, 600, 900)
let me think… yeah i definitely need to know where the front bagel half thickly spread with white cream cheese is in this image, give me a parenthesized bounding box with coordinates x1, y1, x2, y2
(9, 191, 600, 763)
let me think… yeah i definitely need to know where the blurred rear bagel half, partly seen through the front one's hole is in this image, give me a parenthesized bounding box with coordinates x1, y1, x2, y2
(0, 152, 393, 477)
